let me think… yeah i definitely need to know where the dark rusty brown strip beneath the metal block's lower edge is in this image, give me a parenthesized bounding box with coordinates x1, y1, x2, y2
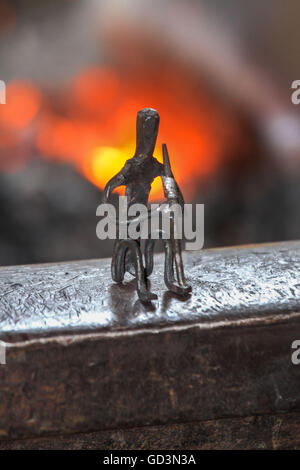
(0, 413, 300, 451)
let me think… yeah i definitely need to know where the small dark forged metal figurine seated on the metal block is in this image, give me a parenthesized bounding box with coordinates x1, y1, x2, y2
(104, 108, 191, 302)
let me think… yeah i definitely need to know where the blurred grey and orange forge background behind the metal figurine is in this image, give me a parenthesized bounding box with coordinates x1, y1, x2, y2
(0, 0, 300, 265)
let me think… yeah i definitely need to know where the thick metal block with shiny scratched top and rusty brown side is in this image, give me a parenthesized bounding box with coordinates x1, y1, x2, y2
(0, 242, 300, 439)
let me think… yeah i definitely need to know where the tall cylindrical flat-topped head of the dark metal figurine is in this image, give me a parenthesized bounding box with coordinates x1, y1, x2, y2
(135, 108, 159, 157)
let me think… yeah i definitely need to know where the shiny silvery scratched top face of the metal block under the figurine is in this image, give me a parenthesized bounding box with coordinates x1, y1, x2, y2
(0, 242, 300, 341)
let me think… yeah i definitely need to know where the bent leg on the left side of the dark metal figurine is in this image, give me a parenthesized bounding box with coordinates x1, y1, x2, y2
(111, 240, 157, 302)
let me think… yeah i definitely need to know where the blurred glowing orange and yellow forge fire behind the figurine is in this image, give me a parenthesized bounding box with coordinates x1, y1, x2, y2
(0, 68, 243, 199)
